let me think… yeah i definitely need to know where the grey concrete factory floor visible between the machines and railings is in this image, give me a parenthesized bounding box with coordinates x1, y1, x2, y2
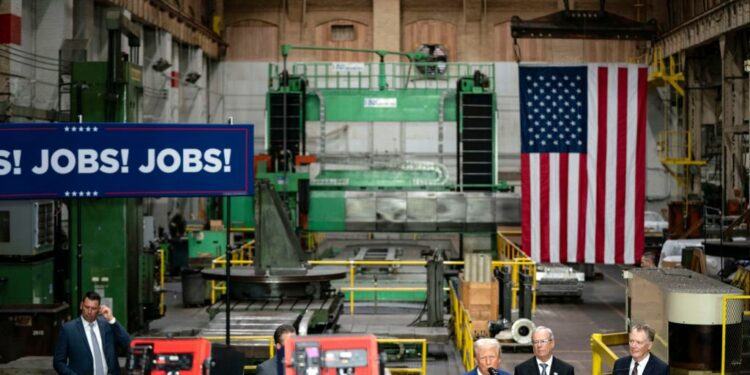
(0, 266, 626, 375)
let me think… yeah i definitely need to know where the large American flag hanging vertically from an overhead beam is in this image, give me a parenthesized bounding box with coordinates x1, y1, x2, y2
(518, 65, 647, 264)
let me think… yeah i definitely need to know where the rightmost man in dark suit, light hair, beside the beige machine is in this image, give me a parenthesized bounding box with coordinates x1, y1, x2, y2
(612, 324, 669, 375)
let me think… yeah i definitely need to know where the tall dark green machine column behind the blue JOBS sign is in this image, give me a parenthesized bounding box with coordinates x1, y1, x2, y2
(69, 9, 159, 332)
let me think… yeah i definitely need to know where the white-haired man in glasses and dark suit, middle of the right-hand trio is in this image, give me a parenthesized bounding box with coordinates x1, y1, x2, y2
(514, 326, 575, 375)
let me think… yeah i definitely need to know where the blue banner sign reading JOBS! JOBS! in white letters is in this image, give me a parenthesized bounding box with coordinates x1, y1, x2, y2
(0, 123, 253, 199)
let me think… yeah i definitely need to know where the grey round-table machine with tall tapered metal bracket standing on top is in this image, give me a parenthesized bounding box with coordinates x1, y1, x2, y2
(201, 180, 346, 352)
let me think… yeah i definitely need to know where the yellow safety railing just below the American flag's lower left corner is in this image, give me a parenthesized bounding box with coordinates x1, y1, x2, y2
(492, 230, 537, 312)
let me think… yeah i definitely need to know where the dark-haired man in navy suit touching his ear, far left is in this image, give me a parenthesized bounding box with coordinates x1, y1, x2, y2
(52, 292, 130, 375)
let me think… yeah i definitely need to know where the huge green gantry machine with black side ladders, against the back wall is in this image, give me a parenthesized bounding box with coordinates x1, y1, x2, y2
(266, 45, 520, 237)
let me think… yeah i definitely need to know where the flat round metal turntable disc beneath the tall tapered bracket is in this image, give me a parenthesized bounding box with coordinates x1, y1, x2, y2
(201, 267, 347, 284)
